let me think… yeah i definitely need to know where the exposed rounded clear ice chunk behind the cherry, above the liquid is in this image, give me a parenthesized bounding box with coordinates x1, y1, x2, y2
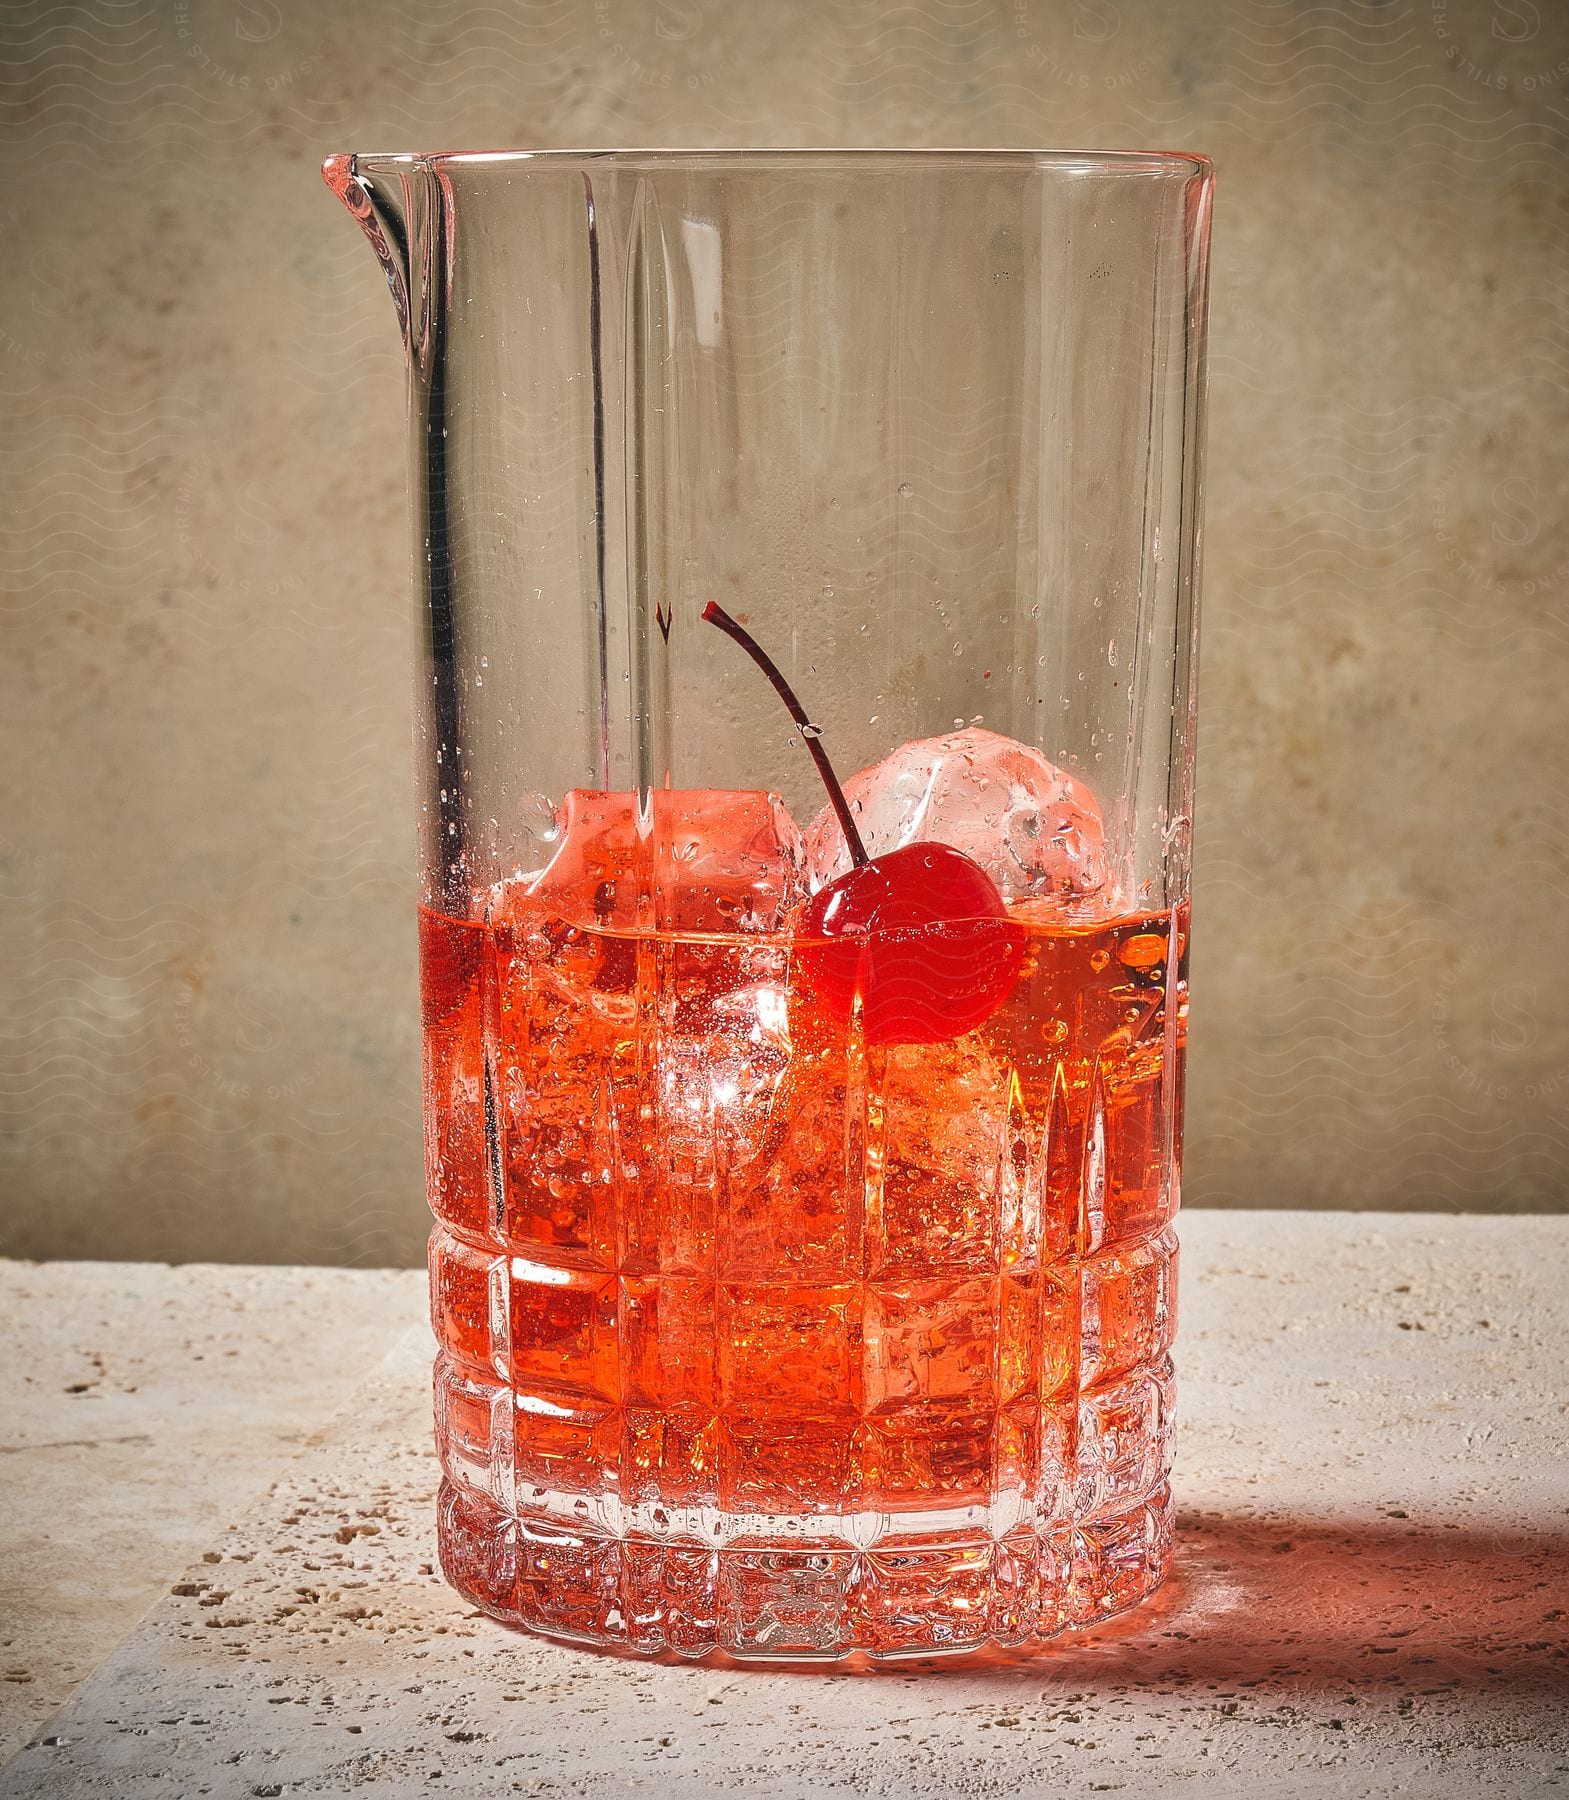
(806, 725, 1107, 900)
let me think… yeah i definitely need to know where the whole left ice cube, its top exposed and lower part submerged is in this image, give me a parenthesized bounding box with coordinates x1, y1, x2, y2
(489, 788, 806, 1202)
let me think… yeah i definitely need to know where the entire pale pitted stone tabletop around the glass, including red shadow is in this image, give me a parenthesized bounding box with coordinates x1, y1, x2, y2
(0, 1213, 1569, 1800)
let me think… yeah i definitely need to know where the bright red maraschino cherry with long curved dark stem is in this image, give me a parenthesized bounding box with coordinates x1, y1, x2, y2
(704, 601, 1024, 1044)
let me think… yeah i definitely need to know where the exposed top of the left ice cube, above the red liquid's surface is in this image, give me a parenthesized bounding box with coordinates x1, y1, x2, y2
(524, 788, 806, 932)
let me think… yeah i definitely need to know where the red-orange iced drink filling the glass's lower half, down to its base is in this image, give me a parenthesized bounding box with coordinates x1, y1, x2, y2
(421, 896, 1186, 1656)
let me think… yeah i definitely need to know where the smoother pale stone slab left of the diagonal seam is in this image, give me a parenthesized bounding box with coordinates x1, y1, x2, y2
(0, 1260, 423, 1759)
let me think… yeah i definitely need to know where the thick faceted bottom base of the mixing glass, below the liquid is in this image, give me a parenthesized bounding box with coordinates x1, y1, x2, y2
(439, 1480, 1173, 1663)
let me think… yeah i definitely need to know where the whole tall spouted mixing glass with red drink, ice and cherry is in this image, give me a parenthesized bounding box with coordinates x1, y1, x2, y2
(326, 151, 1211, 1660)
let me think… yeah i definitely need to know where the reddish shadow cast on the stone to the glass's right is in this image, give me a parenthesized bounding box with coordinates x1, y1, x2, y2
(971, 1514, 1569, 1699)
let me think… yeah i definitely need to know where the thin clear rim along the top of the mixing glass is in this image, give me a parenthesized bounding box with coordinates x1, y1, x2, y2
(327, 146, 1215, 178)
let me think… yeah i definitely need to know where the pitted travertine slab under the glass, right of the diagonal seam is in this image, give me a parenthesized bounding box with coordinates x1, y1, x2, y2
(0, 1213, 1569, 1800)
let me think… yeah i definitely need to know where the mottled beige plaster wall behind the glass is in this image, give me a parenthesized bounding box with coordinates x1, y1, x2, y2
(0, 0, 1569, 1262)
